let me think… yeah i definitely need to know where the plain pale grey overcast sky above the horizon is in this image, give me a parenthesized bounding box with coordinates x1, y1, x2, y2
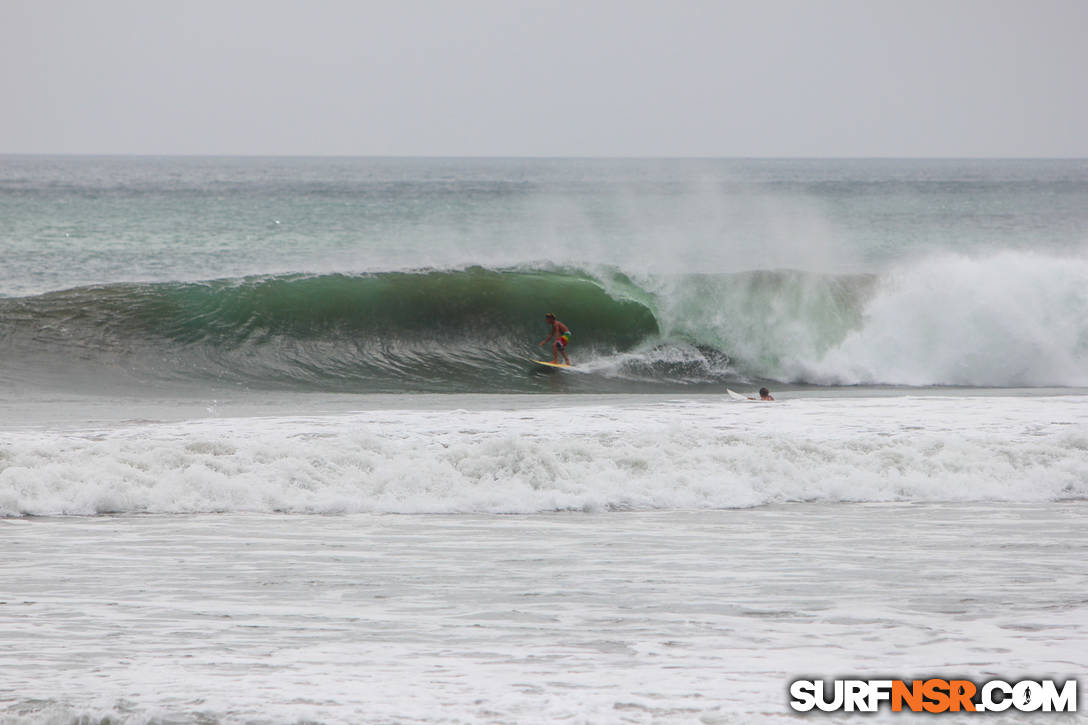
(0, 0, 1088, 157)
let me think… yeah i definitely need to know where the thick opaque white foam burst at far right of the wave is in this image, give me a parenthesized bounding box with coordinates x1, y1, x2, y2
(800, 251, 1088, 386)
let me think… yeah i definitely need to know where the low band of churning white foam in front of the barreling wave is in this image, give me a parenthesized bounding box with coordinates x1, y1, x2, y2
(0, 396, 1088, 516)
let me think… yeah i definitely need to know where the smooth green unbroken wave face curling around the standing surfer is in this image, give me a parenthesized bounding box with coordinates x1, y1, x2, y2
(0, 268, 659, 392)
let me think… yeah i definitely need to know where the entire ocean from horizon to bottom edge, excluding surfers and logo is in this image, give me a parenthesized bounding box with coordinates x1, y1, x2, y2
(0, 156, 1088, 725)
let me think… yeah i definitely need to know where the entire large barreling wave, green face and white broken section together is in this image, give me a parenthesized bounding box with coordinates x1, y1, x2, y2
(0, 253, 1088, 392)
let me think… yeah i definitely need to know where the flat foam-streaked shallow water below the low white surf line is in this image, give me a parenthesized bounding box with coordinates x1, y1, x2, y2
(0, 502, 1088, 725)
